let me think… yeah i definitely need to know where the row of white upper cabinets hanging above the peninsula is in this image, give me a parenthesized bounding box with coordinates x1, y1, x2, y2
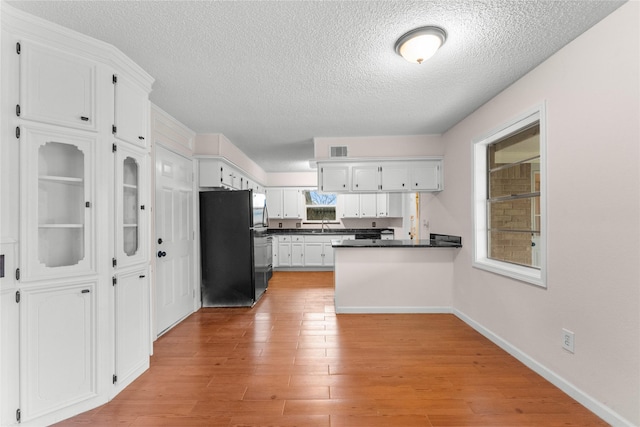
(318, 157, 444, 193)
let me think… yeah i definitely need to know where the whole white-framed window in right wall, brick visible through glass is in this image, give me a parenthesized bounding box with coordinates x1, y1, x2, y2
(474, 107, 546, 286)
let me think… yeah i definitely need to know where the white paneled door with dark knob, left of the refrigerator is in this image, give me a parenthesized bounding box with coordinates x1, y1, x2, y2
(155, 146, 195, 335)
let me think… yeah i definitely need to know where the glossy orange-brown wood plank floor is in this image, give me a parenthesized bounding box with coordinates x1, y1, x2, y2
(55, 272, 606, 427)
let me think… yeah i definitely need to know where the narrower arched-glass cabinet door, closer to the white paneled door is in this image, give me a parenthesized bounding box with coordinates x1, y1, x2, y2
(114, 144, 149, 267)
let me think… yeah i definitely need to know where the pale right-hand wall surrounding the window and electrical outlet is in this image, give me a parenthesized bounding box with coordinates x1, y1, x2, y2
(436, 2, 640, 425)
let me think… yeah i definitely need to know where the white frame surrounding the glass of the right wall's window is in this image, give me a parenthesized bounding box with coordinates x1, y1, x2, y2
(471, 103, 547, 288)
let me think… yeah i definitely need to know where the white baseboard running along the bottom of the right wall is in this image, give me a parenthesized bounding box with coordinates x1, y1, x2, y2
(452, 308, 635, 427)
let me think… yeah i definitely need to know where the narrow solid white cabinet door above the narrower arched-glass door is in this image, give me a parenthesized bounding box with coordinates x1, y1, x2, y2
(114, 75, 149, 147)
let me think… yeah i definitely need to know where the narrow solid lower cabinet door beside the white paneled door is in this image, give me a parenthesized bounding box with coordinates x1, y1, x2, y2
(113, 269, 151, 391)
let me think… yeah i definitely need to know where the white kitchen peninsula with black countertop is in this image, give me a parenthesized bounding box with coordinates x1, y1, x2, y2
(332, 234, 462, 313)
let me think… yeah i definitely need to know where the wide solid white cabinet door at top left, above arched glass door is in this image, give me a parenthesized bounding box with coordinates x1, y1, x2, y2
(20, 41, 97, 131)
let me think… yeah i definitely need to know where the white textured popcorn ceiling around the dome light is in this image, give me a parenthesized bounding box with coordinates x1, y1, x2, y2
(7, 0, 623, 172)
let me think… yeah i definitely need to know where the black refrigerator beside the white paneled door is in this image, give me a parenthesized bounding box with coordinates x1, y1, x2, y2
(200, 190, 271, 307)
